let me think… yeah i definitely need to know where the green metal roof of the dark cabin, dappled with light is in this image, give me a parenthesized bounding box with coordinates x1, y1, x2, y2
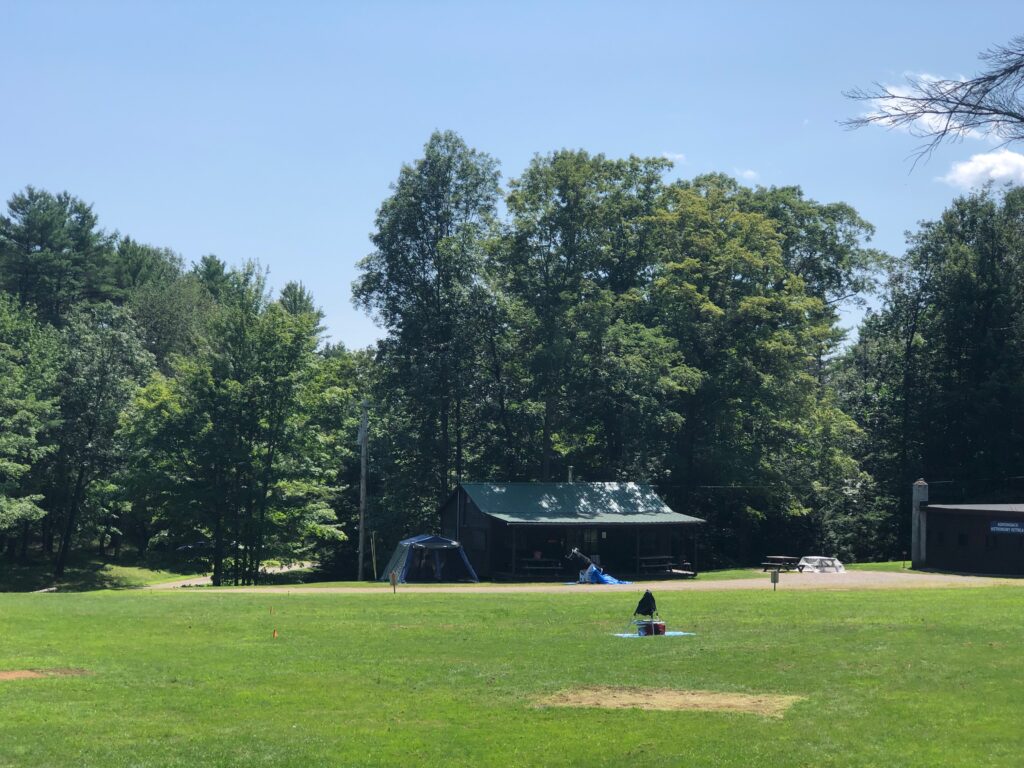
(462, 482, 703, 525)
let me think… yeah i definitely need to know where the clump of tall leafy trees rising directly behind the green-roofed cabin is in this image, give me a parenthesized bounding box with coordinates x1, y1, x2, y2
(354, 134, 884, 560)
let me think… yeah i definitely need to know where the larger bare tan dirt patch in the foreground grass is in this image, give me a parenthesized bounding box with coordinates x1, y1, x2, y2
(539, 687, 804, 718)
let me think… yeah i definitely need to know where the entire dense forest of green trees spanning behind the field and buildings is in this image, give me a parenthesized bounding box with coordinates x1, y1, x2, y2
(0, 132, 1024, 584)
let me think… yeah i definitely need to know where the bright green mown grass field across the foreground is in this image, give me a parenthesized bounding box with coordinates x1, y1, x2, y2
(0, 587, 1024, 768)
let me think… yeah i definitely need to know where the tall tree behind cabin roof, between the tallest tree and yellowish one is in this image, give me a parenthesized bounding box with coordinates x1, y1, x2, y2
(490, 151, 690, 479)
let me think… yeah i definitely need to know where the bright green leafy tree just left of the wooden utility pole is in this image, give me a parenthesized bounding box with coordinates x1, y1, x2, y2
(116, 265, 342, 584)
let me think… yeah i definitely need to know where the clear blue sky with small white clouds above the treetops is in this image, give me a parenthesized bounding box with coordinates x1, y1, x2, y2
(0, 0, 1024, 346)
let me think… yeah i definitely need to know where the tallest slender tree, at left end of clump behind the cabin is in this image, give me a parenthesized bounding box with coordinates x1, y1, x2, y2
(352, 132, 499, 525)
